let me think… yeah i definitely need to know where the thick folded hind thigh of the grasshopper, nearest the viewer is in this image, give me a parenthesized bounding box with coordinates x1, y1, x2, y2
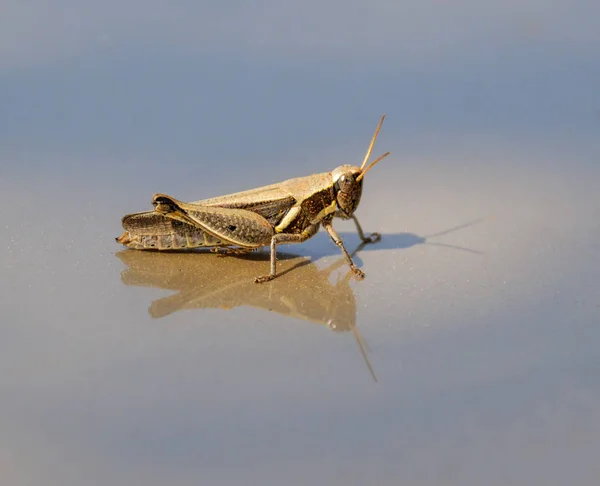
(152, 194, 275, 248)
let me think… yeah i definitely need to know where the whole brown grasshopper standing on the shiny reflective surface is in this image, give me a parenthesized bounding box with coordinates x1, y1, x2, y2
(116, 115, 390, 283)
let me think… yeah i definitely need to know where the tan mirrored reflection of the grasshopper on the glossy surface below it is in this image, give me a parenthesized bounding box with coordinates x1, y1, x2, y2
(116, 244, 377, 381)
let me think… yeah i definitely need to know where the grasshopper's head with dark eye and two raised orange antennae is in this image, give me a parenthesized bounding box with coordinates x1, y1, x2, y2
(331, 115, 390, 219)
